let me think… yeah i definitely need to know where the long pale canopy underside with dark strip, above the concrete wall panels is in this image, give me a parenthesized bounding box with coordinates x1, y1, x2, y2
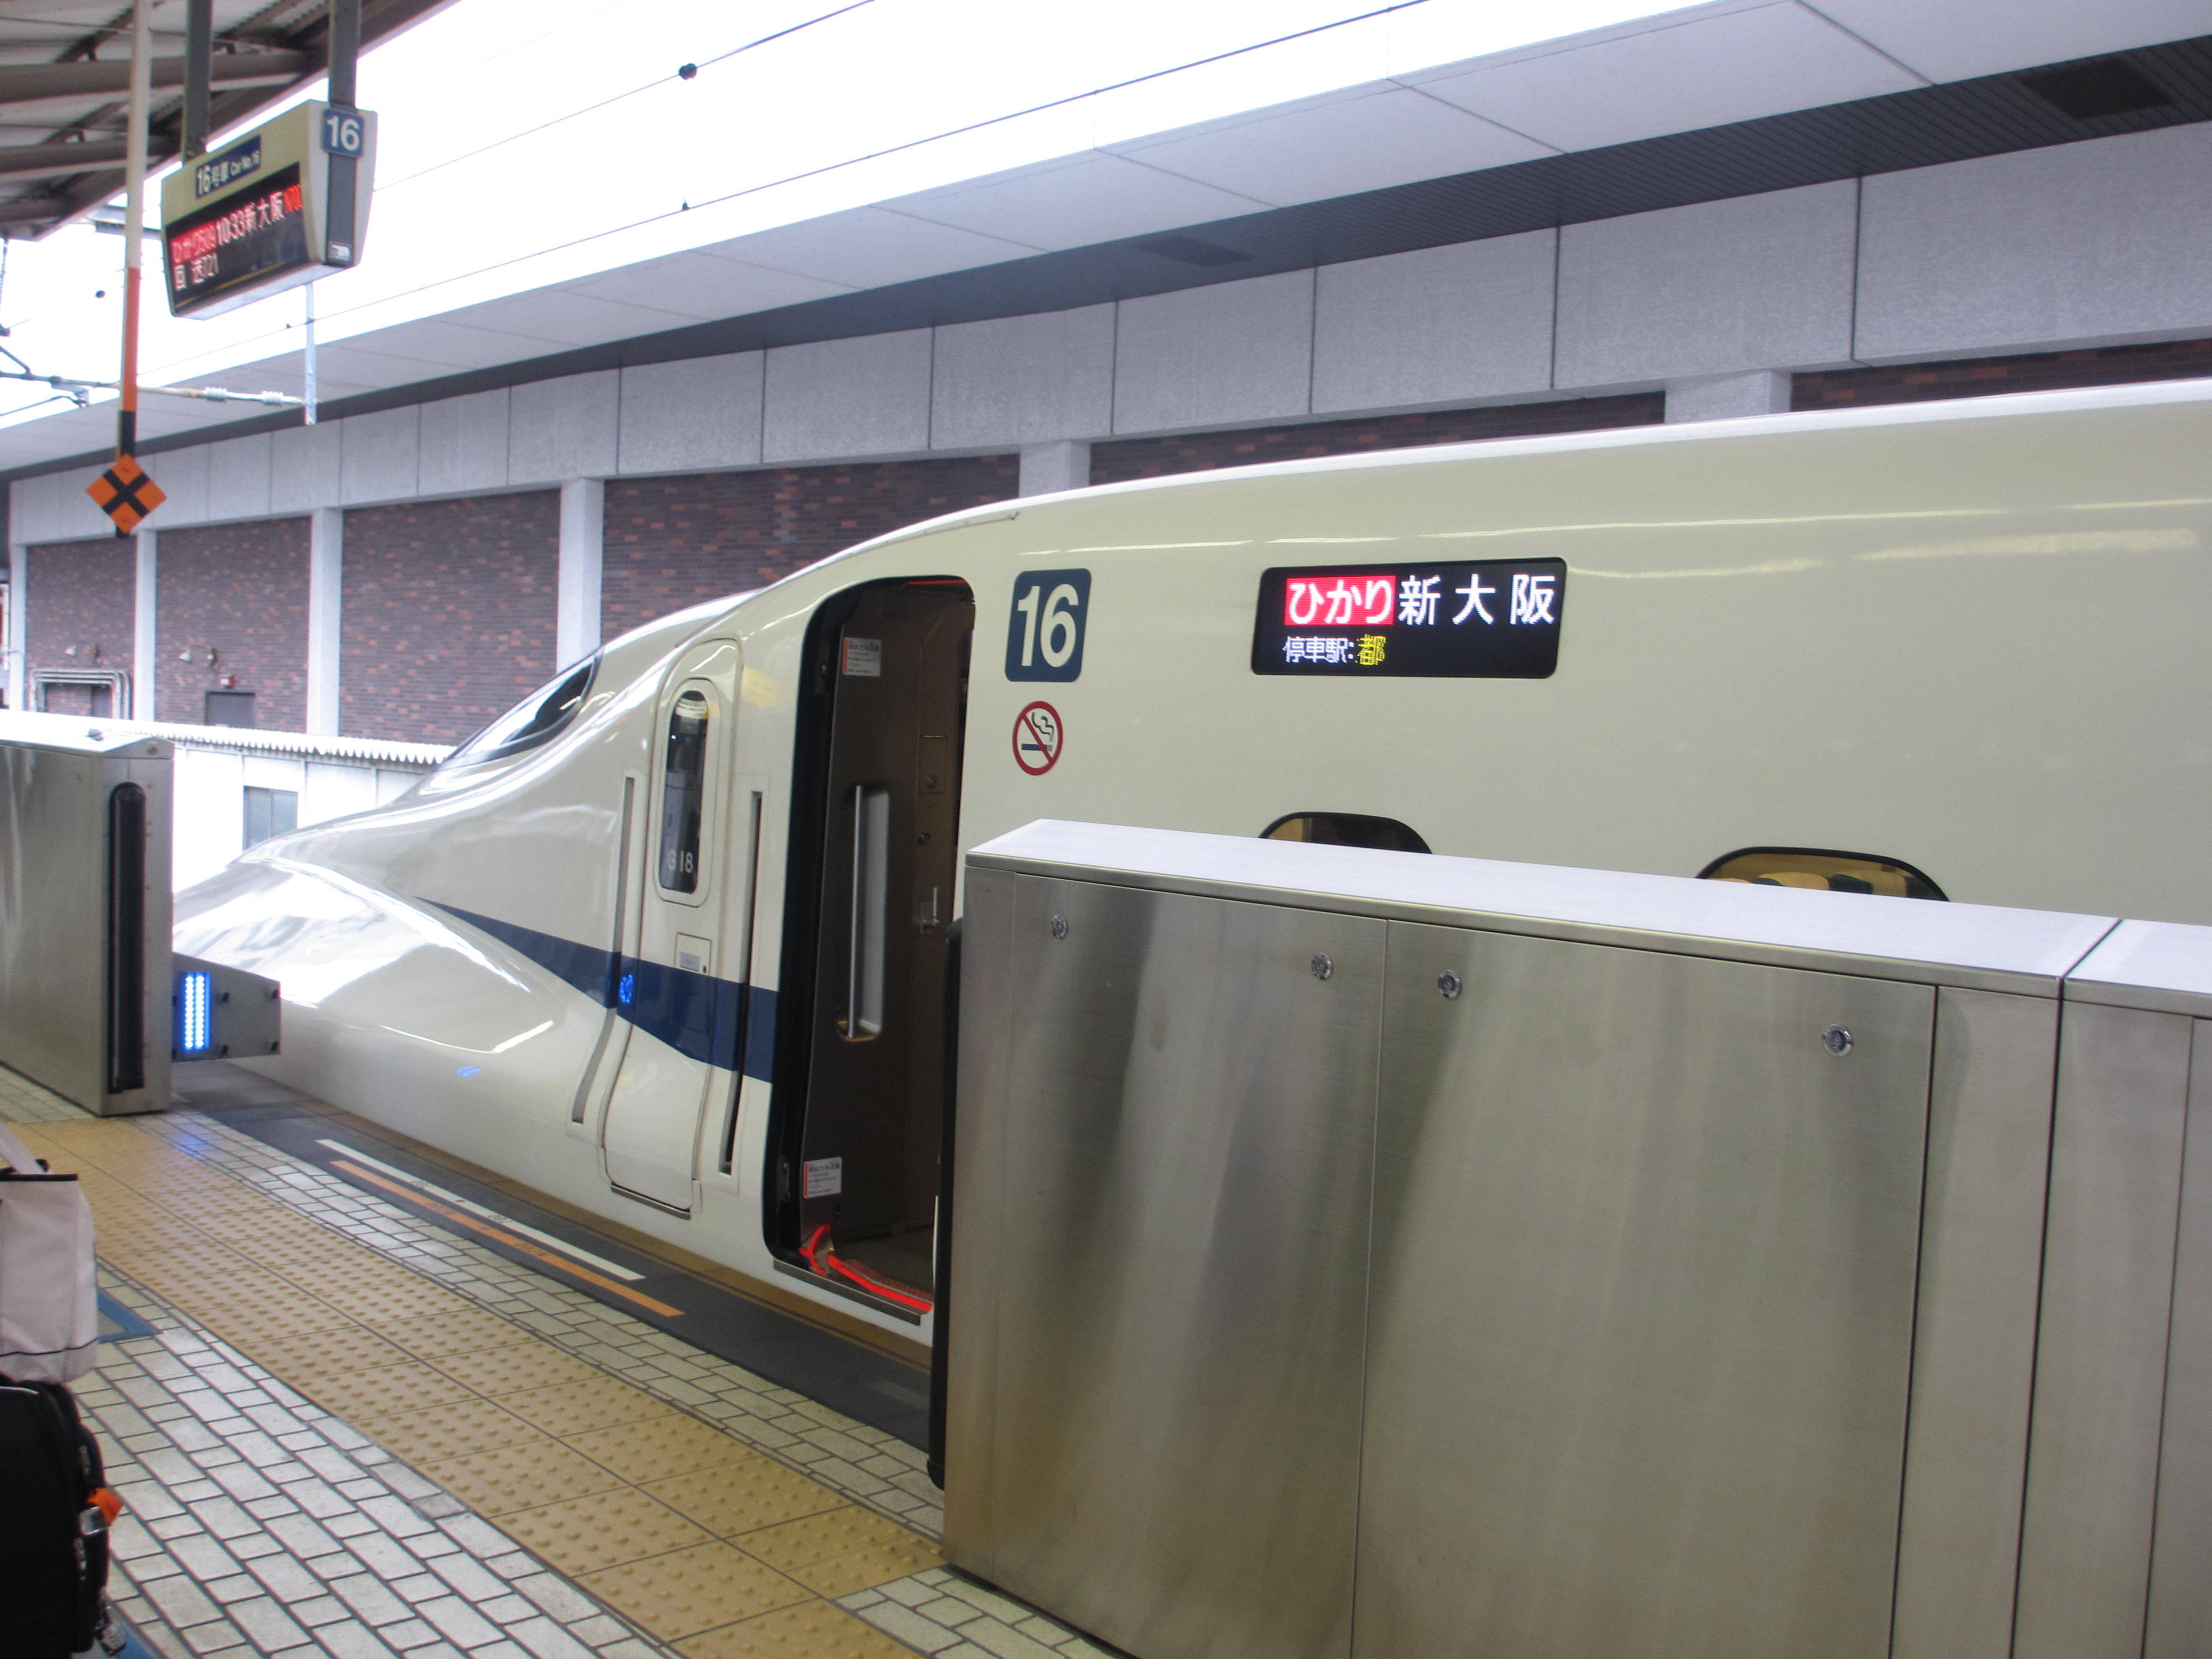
(0, 0, 2212, 478)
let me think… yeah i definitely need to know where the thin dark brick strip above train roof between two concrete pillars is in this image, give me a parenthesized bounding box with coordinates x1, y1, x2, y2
(1091, 392, 1666, 484)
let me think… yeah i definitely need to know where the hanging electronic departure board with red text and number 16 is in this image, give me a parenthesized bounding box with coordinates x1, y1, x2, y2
(161, 102, 376, 316)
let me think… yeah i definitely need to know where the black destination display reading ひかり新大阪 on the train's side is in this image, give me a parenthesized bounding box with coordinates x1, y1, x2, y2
(1252, 560, 1566, 679)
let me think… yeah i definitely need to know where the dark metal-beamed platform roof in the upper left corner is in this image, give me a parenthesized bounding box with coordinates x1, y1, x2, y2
(0, 0, 449, 237)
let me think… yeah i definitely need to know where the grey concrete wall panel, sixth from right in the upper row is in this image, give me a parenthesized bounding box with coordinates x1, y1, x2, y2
(761, 327, 931, 462)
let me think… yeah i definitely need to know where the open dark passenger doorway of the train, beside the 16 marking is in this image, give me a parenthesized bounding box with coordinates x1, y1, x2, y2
(768, 580, 975, 1318)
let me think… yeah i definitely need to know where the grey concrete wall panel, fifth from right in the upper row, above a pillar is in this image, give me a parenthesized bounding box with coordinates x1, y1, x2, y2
(929, 305, 1113, 449)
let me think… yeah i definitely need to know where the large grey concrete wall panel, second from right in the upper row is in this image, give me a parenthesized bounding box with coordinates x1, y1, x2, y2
(1555, 179, 1858, 389)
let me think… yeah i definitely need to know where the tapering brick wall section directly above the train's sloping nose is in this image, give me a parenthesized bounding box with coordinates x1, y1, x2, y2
(599, 456, 1022, 639)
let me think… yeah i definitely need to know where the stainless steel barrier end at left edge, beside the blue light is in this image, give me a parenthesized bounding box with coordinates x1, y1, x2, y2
(0, 714, 170, 1115)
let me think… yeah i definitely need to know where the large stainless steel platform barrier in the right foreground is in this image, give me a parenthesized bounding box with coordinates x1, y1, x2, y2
(940, 823, 2212, 1659)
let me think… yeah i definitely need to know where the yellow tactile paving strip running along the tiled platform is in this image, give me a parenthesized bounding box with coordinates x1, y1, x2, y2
(20, 1119, 940, 1659)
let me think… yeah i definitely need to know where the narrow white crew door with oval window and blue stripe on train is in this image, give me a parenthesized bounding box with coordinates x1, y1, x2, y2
(599, 639, 752, 1212)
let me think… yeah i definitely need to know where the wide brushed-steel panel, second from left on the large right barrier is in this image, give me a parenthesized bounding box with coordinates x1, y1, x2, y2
(1356, 922, 1936, 1659)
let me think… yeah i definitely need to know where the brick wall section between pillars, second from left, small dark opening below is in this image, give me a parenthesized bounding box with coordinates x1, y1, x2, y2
(155, 518, 307, 732)
